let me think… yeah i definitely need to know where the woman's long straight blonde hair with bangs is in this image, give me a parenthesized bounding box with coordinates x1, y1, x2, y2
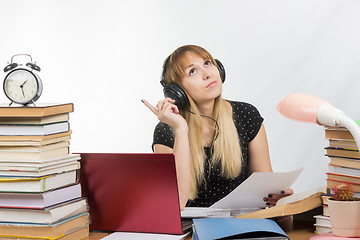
(164, 45, 242, 199)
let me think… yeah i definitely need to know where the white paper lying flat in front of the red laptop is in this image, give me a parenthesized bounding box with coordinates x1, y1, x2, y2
(101, 232, 190, 240)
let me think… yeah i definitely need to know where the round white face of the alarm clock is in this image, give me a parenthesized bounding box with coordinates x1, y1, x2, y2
(4, 69, 42, 104)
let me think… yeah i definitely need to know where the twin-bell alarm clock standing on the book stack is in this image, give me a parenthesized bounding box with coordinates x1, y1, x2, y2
(3, 54, 43, 105)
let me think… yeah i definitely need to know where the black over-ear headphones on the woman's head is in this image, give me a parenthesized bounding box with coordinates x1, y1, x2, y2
(160, 55, 226, 109)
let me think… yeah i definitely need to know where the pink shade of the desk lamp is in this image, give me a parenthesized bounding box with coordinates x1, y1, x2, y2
(277, 94, 330, 123)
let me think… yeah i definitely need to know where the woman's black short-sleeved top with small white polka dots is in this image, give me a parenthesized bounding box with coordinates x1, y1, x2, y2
(152, 101, 264, 207)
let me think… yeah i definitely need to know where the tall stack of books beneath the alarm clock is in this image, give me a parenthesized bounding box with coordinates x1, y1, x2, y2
(0, 103, 90, 240)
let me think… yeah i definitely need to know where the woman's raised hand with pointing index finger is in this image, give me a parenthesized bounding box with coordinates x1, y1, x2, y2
(141, 98, 187, 131)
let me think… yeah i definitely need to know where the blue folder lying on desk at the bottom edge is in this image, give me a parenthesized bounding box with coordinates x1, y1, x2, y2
(193, 218, 289, 240)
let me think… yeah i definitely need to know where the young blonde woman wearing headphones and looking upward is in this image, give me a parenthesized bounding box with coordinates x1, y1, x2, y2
(142, 45, 292, 209)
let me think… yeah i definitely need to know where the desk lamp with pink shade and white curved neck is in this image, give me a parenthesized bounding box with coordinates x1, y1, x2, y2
(277, 94, 360, 149)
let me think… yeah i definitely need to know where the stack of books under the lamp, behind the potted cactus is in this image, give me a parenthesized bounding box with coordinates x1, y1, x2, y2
(315, 120, 360, 233)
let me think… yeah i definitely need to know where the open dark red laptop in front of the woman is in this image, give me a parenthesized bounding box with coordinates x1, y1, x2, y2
(80, 153, 191, 234)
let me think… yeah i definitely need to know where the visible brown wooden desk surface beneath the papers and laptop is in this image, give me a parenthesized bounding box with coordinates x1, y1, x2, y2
(83, 216, 315, 240)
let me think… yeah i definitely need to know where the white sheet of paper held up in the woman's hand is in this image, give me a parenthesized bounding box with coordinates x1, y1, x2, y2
(210, 168, 303, 209)
